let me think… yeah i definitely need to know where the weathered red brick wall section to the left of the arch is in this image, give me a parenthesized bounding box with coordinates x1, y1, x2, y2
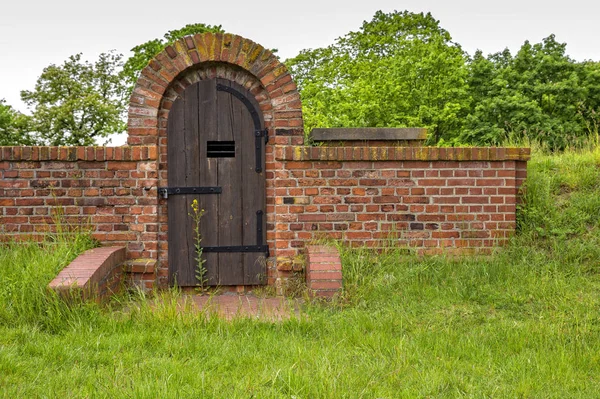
(0, 146, 158, 259)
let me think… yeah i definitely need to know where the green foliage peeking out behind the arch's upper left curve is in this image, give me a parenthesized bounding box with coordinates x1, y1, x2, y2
(123, 23, 224, 93)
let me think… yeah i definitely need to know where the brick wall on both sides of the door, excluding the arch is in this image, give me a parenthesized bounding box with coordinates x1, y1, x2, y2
(0, 144, 529, 288)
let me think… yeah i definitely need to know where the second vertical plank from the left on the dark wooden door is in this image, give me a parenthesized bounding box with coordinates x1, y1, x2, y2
(198, 79, 221, 285)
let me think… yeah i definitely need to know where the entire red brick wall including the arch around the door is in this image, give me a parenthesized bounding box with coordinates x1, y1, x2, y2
(0, 33, 529, 287)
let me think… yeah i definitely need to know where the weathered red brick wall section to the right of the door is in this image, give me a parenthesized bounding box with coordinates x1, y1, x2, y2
(267, 146, 529, 270)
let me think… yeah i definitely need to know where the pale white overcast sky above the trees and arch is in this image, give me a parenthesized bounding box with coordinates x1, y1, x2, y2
(0, 0, 600, 144)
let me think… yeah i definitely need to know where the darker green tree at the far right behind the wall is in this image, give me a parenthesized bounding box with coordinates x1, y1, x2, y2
(460, 35, 600, 149)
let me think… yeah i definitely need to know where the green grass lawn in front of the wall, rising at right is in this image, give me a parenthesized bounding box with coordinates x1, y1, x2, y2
(0, 150, 600, 398)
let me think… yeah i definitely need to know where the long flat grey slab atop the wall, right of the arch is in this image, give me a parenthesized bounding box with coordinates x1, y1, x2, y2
(310, 127, 427, 141)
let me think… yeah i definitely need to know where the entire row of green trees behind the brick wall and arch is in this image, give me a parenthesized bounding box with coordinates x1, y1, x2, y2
(7, 16, 600, 149)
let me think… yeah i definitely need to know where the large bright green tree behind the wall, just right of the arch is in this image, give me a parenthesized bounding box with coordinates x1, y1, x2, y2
(286, 11, 468, 141)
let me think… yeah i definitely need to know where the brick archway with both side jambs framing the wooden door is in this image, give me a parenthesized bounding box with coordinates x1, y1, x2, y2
(128, 33, 304, 286)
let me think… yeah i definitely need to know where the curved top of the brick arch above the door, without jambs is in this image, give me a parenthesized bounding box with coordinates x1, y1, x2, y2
(127, 33, 303, 145)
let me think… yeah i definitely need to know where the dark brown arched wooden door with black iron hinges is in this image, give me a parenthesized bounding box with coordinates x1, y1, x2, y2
(164, 79, 268, 287)
